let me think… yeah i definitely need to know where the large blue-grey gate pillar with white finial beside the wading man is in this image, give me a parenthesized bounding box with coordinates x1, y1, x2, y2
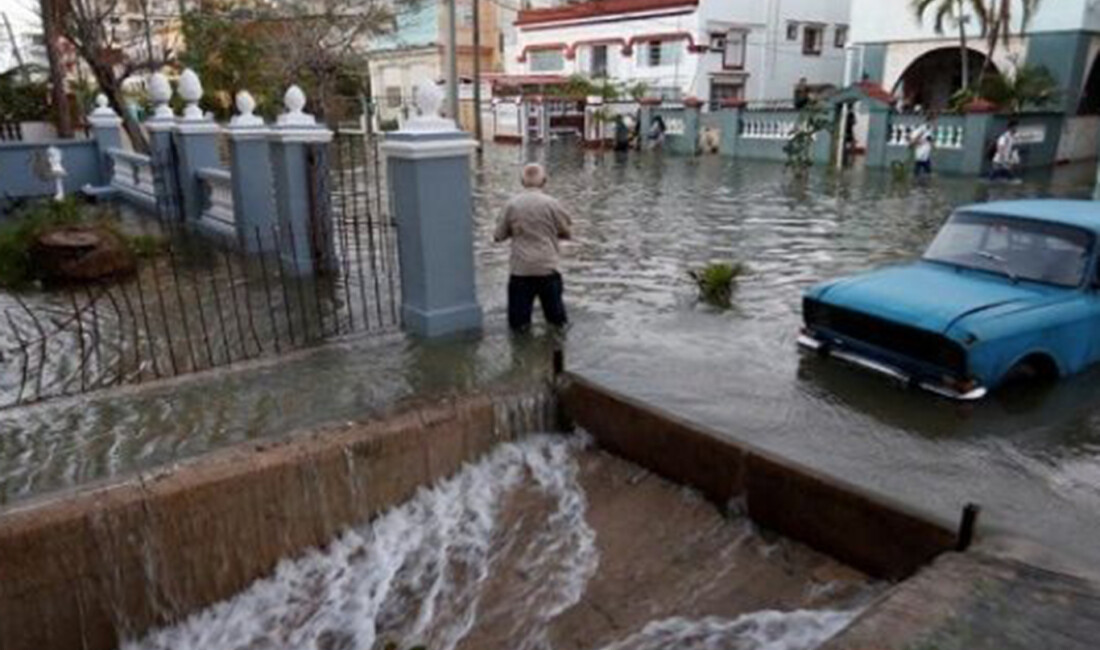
(383, 82, 482, 338)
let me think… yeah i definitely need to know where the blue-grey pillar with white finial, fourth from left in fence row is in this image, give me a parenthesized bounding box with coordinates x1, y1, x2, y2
(226, 90, 278, 253)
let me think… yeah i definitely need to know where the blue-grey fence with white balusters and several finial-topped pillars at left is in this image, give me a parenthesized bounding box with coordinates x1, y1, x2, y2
(0, 69, 332, 274)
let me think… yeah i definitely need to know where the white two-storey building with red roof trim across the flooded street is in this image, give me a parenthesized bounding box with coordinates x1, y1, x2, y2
(505, 0, 849, 102)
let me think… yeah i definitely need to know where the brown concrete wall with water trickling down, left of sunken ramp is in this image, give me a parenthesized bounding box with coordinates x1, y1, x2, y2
(0, 390, 554, 650)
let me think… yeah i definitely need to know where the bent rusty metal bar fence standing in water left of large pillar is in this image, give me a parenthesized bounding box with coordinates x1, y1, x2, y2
(0, 129, 400, 408)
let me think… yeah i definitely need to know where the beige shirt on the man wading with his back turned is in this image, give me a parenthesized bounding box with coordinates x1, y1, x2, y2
(493, 189, 573, 276)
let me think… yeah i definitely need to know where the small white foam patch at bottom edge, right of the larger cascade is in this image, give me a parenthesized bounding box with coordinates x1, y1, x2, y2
(603, 609, 859, 650)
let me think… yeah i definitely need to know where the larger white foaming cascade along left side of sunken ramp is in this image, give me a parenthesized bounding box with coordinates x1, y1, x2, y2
(123, 436, 598, 650)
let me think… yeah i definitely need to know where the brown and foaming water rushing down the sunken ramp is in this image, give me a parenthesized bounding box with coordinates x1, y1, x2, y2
(123, 434, 882, 650)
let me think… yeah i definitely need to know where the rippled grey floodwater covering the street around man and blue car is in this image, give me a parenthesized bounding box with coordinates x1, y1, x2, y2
(0, 146, 1100, 565)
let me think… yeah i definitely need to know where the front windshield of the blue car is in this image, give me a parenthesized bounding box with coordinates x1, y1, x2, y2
(924, 212, 1092, 287)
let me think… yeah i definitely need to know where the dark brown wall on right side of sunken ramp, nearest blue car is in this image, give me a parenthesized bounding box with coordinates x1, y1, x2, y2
(561, 376, 956, 580)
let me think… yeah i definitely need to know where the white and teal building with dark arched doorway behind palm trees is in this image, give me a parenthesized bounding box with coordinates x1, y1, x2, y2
(849, 0, 1100, 168)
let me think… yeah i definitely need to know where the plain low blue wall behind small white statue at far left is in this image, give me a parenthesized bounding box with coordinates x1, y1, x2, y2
(0, 140, 107, 197)
